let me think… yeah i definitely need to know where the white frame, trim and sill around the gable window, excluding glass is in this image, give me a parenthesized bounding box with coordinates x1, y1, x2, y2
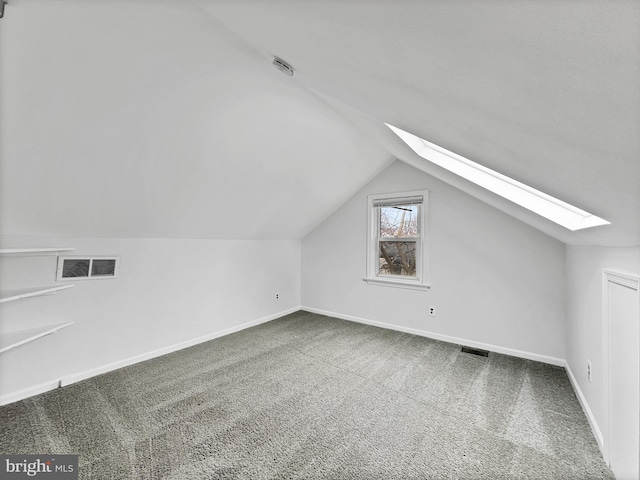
(364, 190, 431, 290)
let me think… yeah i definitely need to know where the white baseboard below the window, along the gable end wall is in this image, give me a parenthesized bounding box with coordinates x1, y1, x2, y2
(300, 306, 565, 367)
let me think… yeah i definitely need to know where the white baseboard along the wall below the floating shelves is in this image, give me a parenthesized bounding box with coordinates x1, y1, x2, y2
(0, 307, 300, 405)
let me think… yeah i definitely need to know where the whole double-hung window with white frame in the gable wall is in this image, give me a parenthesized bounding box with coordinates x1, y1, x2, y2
(365, 190, 429, 289)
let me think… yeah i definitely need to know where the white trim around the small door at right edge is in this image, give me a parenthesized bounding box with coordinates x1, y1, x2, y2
(602, 269, 640, 466)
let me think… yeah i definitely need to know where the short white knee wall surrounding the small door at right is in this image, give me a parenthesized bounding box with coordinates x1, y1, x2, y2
(565, 245, 640, 444)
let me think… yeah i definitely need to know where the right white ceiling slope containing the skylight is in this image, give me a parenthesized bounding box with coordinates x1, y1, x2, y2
(198, 0, 640, 245)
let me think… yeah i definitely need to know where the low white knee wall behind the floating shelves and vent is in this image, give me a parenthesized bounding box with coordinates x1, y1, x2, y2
(0, 237, 300, 403)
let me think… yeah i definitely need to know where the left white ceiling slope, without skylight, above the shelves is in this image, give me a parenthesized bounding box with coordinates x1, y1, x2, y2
(0, 0, 393, 239)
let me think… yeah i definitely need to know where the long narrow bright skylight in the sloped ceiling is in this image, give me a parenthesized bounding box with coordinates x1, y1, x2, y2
(385, 123, 610, 231)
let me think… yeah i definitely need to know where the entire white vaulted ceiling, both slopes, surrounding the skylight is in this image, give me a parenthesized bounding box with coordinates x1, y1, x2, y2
(0, 0, 640, 246)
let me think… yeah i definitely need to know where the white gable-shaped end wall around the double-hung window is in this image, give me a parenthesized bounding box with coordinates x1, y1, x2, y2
(302, 162, 565, 364)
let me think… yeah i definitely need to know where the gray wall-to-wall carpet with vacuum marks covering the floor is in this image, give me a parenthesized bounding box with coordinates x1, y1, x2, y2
(0, 312, 613, 480)
